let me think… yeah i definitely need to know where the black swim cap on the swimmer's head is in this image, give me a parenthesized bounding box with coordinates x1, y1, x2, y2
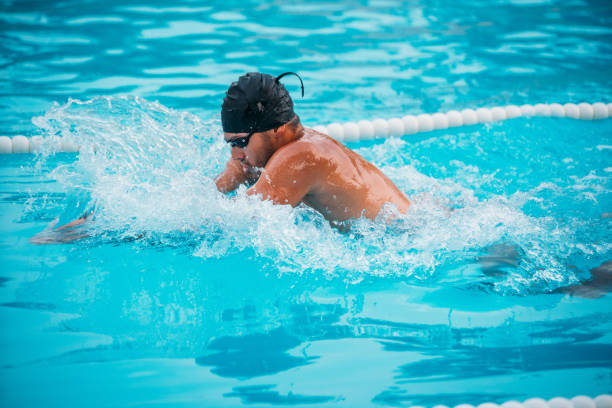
(221, 72, 304, 133)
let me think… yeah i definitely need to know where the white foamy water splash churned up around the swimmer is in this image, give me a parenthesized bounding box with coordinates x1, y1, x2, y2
(27, 96, 610, 294)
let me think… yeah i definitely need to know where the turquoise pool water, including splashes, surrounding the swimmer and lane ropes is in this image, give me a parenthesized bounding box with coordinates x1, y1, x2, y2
(0, 1, 612, 407)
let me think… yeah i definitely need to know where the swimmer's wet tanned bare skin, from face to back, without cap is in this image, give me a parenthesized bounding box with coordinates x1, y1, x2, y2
(215, 124, 410, 221)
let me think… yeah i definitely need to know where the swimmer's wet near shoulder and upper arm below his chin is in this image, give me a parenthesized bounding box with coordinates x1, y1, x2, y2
(247, 148, 319, 207)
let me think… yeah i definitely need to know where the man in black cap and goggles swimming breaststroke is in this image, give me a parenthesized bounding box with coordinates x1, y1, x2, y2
(215, 72, 410, 223)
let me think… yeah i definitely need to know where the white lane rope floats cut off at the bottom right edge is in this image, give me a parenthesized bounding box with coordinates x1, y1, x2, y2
(420, 394, 612, 408)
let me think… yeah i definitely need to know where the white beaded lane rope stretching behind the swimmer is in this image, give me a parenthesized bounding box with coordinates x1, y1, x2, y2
(0, 102, 612, 154)
